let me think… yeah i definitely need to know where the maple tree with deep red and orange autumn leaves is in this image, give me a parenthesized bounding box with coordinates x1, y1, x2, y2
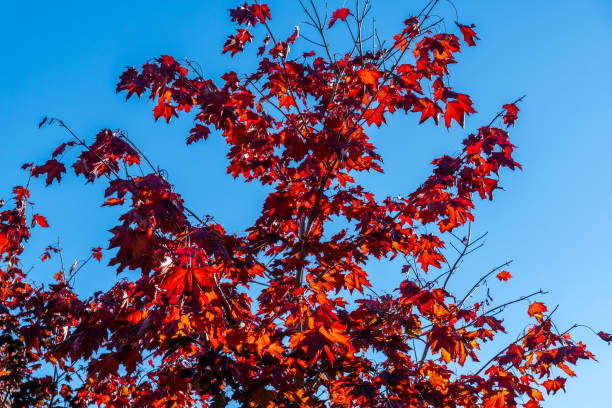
(0, 0, 612, 408)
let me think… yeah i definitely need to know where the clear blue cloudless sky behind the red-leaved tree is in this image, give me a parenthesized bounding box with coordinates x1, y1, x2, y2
(0, 0, 612, 408)
